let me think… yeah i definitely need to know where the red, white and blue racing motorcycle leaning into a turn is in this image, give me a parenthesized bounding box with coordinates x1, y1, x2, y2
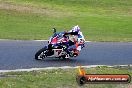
(35, 28, 77, 60)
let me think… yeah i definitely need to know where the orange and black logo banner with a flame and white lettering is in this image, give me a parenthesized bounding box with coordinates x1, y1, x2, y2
(76, 66, 131, 85)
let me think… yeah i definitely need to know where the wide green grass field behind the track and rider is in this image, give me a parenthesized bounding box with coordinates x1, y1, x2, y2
(0, 0, 132, 42)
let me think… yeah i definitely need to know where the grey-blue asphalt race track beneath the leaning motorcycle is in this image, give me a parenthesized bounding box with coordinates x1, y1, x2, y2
(0, 40, 132, 70)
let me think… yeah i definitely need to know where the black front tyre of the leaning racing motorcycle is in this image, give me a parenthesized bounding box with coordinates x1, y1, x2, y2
(35, 47, 47, 60)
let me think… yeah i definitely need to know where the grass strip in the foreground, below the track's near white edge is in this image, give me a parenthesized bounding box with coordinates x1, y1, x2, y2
(0, 67, 132, 88)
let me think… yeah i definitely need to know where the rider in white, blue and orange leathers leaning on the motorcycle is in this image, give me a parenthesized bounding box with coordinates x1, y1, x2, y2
(64, 25, 85, 56)
